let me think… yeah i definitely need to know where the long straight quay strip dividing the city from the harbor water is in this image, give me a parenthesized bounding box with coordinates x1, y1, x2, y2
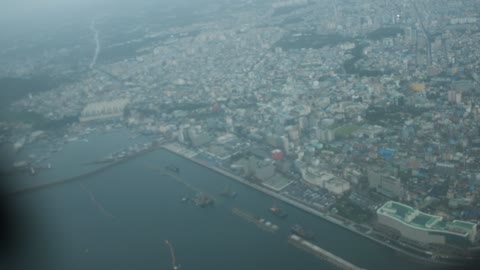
(160, 145, 462, 266)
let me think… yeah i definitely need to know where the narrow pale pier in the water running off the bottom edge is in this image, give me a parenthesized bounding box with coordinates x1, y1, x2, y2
(288, 234, 364, 270)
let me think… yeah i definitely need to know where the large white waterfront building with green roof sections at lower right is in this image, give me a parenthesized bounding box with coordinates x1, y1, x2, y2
(377, 201, 477, 245)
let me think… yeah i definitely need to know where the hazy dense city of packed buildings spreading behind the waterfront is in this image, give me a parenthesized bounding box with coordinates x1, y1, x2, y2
(0, 0, 480, 266)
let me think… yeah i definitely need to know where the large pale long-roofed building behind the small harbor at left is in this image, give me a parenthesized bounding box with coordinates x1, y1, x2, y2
(79, 99, 129, 122)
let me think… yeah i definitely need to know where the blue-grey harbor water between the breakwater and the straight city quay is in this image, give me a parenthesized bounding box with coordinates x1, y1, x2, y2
(1, 137, 434, 270)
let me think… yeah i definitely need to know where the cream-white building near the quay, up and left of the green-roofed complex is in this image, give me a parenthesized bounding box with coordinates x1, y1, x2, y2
(301, 167, 350, 195)
